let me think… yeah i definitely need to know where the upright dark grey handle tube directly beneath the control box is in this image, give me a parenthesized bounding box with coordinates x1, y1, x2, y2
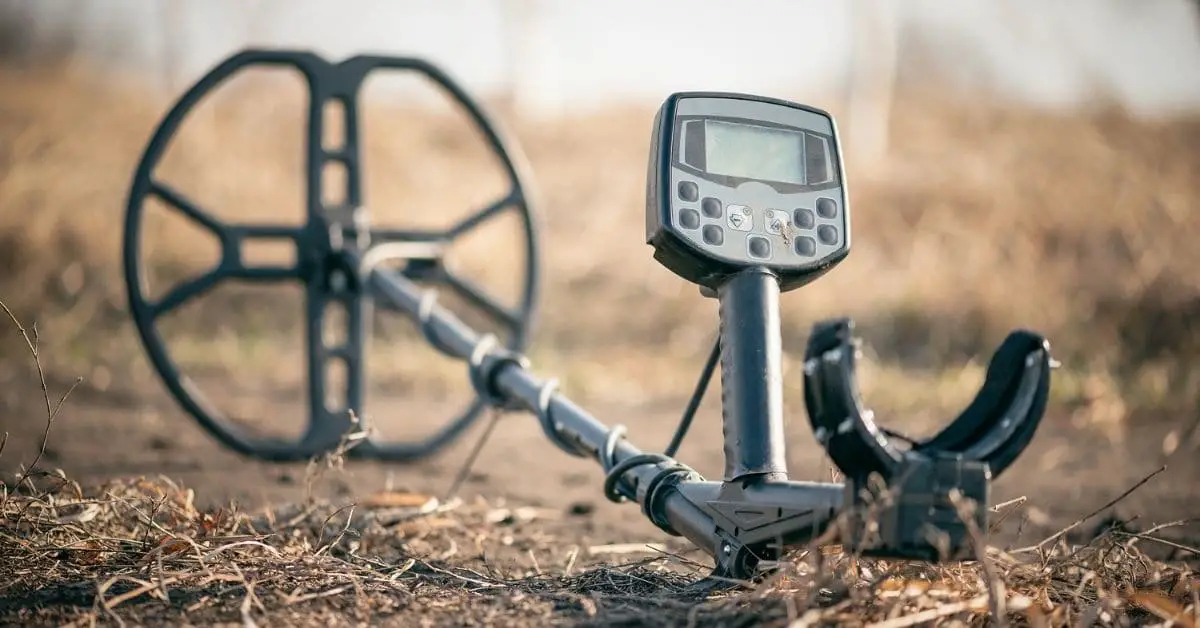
(716, 268, 787, 482)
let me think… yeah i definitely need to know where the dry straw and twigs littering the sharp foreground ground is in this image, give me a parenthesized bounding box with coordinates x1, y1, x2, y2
(0, 304, 1200, 628)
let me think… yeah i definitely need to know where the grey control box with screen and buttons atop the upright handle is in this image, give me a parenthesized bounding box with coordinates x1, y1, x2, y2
(646, 92, 850, 289)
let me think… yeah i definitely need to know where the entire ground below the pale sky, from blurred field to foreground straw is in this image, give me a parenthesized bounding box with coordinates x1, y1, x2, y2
(0, 57, 1200, 626)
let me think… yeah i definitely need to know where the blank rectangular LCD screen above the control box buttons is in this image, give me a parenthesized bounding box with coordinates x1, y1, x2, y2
(704, 120, 805, 185)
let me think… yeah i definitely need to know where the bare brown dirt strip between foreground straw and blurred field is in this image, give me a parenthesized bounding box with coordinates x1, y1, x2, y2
(5, 369, 1200, 543)
